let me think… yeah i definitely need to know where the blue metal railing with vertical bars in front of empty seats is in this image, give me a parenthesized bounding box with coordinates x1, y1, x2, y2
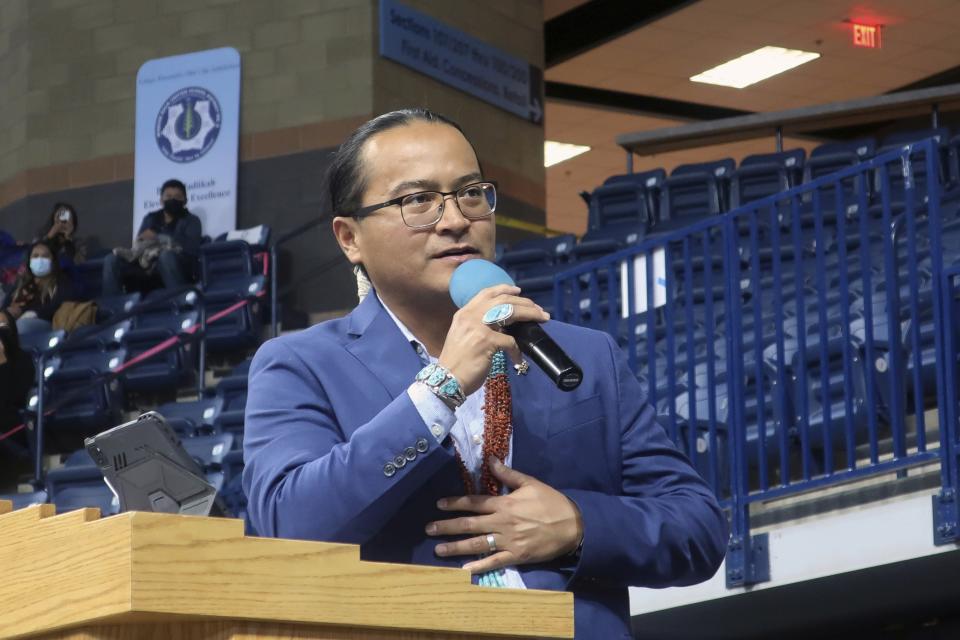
(554, 140, 960, 586)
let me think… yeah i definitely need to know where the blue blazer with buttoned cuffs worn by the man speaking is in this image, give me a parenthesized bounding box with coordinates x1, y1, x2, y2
(243, 295, 727, 640)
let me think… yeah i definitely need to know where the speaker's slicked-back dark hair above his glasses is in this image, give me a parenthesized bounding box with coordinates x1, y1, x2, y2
(326, 107, 483, 216)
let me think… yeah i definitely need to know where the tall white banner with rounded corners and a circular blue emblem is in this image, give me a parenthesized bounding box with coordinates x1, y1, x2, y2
(133, 47, 240, 238)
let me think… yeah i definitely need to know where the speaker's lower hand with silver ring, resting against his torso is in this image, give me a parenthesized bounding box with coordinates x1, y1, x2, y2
(427, 457, 583, 573)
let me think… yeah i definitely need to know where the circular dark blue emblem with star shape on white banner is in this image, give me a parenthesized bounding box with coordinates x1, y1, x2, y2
(155, 87, 222, 162)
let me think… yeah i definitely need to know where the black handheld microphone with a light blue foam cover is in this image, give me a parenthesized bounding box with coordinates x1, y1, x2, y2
(450, 258, 583, 391)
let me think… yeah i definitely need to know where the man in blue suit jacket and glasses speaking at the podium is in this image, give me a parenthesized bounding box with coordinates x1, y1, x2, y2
(243, 110, 726, 640)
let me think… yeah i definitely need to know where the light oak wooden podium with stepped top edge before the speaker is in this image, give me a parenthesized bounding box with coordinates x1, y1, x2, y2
(0, 501, 573, 640)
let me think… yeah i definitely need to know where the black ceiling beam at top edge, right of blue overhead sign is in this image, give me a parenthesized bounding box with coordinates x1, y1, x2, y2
(543, 0, 697, 69)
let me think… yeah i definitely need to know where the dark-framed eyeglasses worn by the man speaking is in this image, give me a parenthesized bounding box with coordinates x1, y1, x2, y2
(351, 181, 497, 229)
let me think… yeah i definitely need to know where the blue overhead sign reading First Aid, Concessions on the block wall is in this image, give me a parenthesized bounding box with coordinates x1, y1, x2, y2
(380, 0, 543, 124)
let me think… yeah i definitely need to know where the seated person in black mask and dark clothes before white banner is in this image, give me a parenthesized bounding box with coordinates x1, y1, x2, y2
(103, 180, 202, 296)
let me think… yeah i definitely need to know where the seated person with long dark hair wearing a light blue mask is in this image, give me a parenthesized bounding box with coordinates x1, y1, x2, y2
(6, 240, 77, 335)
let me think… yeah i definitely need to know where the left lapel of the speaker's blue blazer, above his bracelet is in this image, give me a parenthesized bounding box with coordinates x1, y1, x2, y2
(347, 292, 423, 399)
